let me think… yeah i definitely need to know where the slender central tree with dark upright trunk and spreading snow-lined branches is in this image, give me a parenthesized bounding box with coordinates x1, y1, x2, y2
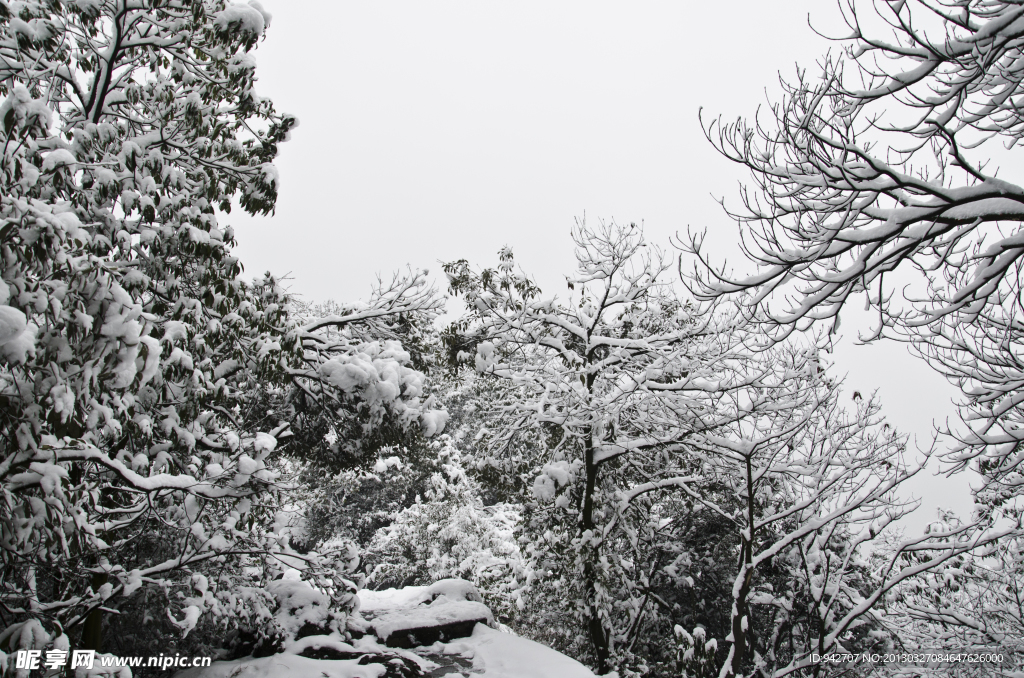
(444, 224, 757, 673)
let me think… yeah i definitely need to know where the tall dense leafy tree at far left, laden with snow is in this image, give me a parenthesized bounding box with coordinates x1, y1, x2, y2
(0, 0, 443, 649)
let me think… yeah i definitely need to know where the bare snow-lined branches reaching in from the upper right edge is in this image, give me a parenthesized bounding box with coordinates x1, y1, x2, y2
(687, 0, 1024, 508)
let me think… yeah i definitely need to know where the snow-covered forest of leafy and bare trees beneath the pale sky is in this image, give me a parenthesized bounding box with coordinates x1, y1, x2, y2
(0, 0, 1024, 678)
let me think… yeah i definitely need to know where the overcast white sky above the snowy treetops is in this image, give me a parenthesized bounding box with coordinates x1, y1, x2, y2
(224, 0, 970, 525)
